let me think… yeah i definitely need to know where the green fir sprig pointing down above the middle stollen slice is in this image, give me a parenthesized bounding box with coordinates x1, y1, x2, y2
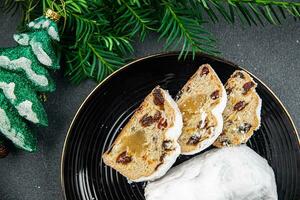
(158, 1, 217, 58)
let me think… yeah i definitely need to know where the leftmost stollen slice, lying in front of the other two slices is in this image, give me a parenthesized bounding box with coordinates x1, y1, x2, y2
(102, 86, 182, 182)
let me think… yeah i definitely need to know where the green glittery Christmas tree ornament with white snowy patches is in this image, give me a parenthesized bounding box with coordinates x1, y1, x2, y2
(0, 10, 60, 152)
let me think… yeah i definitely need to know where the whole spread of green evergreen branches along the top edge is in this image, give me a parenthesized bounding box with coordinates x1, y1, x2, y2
(2, 0, 300, 83)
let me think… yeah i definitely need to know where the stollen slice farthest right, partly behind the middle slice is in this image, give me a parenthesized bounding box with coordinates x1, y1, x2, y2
(214, 70, 261, 147)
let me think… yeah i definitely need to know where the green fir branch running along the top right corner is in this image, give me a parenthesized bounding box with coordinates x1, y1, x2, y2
(190, 0, 300, 26)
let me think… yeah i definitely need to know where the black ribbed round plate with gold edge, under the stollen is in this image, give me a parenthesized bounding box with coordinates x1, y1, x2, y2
(61, 53, 300, 200)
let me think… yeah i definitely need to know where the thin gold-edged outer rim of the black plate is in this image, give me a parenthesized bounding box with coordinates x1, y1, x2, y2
(60, 51, 300, 199)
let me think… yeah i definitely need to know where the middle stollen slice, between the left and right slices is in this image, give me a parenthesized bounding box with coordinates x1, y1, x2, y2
(177, 64, 227, 155)
